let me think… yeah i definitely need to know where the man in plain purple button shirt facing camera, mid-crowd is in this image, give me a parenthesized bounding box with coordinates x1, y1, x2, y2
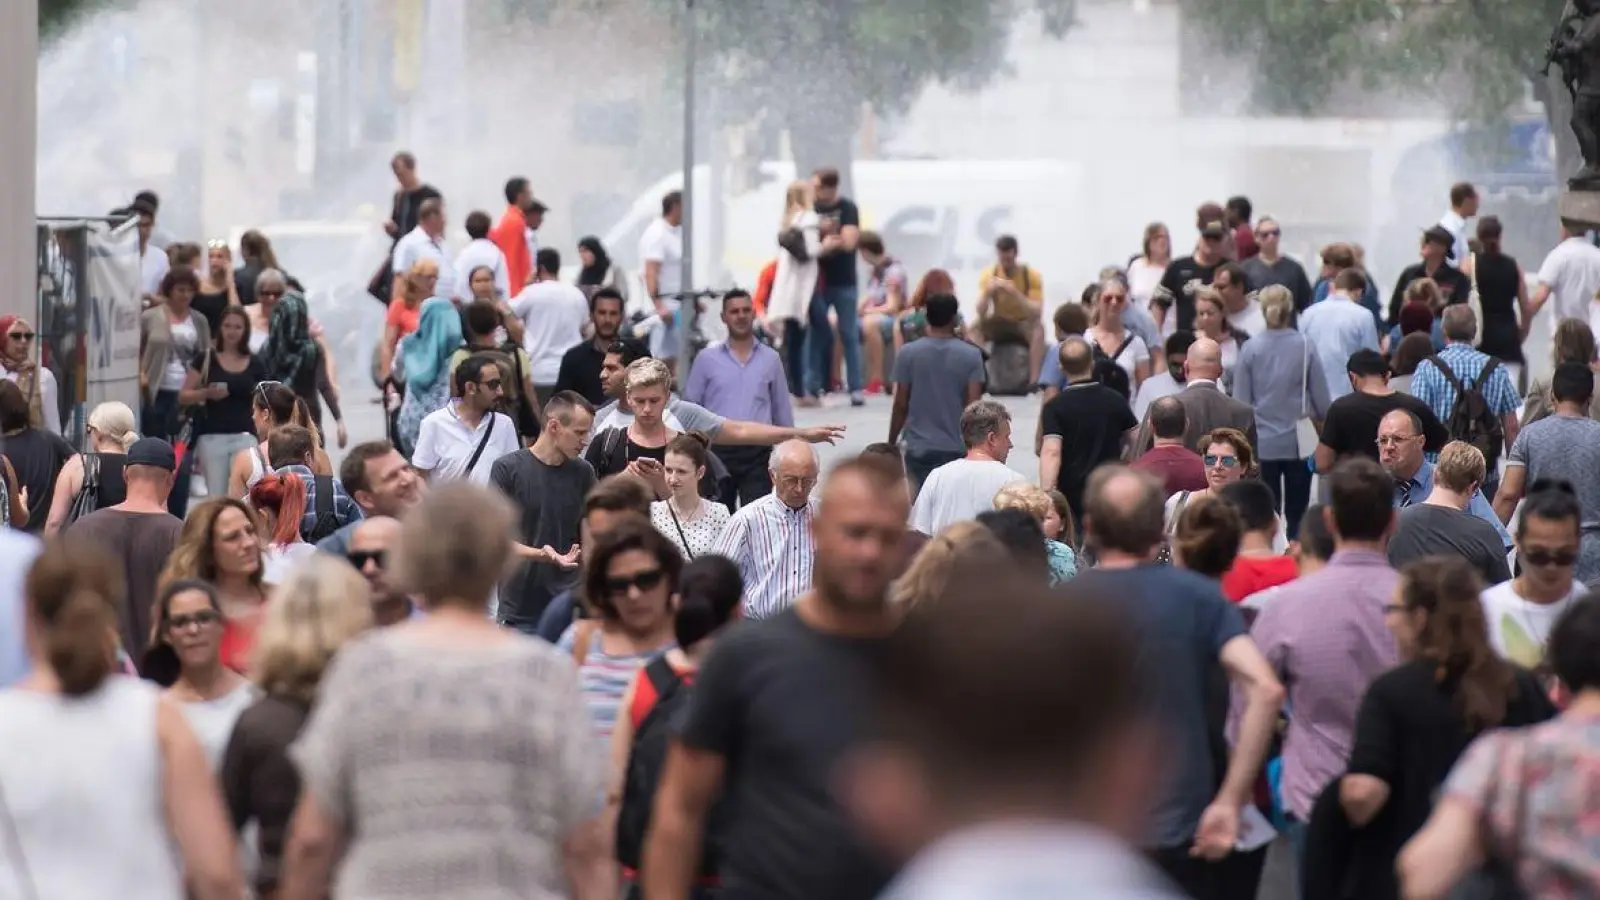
(683, 290, 795, 509)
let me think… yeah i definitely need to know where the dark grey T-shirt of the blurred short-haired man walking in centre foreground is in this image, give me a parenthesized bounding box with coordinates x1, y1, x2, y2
(682, 607, 891, 900)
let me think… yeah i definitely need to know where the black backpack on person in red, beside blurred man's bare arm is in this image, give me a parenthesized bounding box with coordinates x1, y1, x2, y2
(616, 657, 728, 878)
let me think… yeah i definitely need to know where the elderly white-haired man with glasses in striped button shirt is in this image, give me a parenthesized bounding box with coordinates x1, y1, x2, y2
(712, 440, 821, 618)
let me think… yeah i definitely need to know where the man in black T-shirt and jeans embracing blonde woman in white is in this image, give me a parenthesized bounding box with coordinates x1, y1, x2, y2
(808, 168, 867, 407)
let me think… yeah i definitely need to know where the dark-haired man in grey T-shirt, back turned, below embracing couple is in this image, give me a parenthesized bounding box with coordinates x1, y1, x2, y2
(890, 293, 984, 484)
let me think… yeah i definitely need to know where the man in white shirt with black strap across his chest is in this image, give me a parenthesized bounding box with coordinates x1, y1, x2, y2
(411, 354, 522, 485)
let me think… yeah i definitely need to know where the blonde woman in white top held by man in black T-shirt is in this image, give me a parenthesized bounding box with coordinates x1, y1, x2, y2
(766, 181, 822, 404)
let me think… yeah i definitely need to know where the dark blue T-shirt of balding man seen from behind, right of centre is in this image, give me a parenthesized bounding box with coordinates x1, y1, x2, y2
(1075, 564, 1245, 849)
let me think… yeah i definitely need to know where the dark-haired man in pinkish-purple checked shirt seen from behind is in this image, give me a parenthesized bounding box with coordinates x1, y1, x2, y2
(1251, 458, 1400, 849)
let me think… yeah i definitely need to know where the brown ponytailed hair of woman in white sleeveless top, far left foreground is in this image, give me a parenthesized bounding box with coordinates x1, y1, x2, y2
(27, 536, 126, 697)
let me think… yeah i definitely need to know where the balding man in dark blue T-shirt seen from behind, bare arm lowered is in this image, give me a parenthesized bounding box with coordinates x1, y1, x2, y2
(1074, 464, 1283, 897)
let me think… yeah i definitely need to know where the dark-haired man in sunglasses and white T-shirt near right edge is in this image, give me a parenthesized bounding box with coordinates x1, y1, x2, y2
(1483, 480, 1586, 669)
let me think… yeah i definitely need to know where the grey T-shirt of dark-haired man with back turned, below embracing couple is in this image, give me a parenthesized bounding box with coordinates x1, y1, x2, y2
(894, 336, 984, 453)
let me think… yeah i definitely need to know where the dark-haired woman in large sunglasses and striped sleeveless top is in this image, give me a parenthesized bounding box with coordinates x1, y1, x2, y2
(557, 517, 683, 740)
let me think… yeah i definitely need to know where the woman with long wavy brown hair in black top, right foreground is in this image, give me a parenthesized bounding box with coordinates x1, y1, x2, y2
(1331, 557, 1555, 900)
